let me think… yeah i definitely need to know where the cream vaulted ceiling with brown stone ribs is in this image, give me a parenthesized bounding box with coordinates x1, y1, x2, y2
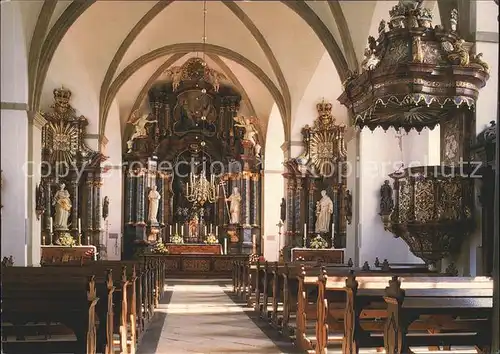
(20, 0, 442, 139)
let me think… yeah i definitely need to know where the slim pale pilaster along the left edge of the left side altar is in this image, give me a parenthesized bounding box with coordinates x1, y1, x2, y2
(27, 112, 46, 266)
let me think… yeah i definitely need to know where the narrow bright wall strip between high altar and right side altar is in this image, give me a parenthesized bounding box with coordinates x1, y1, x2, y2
(262, 104, 285, 261)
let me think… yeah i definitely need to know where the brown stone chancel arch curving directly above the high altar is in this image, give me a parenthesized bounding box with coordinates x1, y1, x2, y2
(99, 43, 289, 141)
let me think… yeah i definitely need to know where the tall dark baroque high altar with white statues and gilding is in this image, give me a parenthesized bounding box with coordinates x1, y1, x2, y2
(123, 58, 262, 258)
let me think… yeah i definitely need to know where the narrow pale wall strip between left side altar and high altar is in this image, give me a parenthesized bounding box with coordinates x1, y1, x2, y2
(101, 100, 123, 259)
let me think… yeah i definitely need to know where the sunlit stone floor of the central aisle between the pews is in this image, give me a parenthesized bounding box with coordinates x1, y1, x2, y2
(138, 279, 294, 354)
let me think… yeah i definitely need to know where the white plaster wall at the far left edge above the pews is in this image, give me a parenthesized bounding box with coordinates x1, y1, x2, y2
(1, 2, 30, 266)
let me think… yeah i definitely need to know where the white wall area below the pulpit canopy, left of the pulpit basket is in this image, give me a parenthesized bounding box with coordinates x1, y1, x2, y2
(357, 130, 422, 264)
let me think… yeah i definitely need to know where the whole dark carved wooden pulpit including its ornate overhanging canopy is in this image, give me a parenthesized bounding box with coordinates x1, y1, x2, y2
(339, 0, 489, 265)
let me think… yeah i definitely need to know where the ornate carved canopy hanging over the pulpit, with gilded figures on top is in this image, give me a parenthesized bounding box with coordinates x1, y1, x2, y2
(339, 0, 489, 131)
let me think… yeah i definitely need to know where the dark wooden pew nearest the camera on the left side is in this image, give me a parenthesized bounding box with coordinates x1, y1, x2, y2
(2, 268, 99, 354)
